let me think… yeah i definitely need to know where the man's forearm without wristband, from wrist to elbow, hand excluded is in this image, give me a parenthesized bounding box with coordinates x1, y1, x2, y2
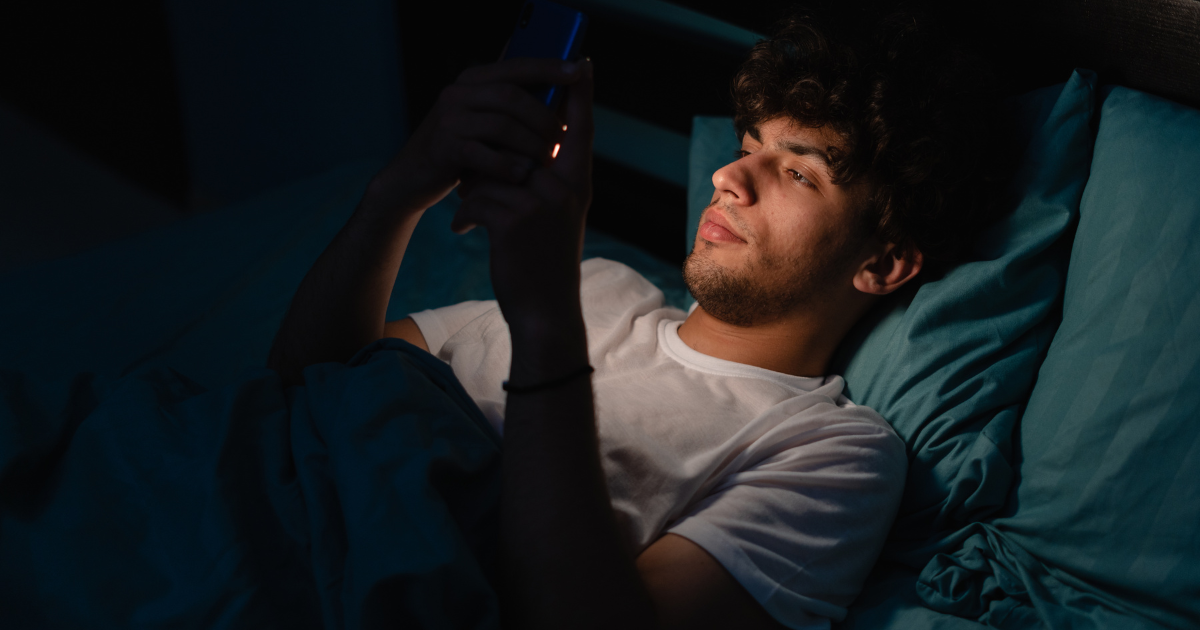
(268, 181, 424, 383)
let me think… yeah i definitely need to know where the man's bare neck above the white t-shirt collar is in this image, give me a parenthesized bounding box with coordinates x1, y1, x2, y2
(679, 306, 857, 377)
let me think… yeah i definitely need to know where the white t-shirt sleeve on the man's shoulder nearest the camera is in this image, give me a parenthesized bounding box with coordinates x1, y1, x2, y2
(668, 415, 907, 629)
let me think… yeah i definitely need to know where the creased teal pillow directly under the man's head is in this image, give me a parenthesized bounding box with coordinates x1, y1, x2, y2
(689, 71, 1094, 570)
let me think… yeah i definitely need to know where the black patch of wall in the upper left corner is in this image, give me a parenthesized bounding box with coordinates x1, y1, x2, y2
(0, 0, 187, 206)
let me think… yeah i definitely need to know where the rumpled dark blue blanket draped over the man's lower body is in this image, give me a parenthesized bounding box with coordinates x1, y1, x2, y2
(0, 340, 500, 628)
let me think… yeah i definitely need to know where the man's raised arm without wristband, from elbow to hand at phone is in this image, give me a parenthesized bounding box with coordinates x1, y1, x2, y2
(268, 59, 578, 383)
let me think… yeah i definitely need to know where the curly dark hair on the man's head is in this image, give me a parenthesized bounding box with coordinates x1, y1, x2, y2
(732, 10, 1007, 272)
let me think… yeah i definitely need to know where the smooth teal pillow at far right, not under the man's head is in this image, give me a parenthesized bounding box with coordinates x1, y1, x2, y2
(923, 88, 1200, 628)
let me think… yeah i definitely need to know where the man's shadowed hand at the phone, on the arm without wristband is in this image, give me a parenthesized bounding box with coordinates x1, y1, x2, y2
(368, 59, 581, 219)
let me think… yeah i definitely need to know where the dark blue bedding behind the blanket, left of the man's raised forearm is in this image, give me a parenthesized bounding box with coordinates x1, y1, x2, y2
(0, 163, 374, 388)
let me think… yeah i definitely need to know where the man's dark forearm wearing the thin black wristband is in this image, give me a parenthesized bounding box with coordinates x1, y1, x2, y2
(502, 316, 654, 628)
